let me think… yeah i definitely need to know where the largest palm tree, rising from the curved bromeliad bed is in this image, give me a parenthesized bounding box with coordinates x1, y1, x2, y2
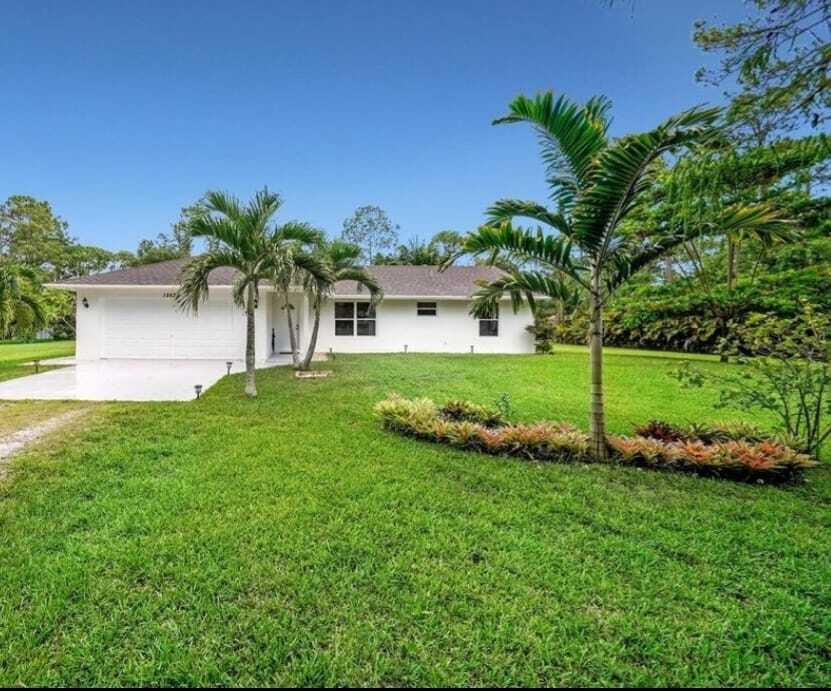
(462, 92, 783, 459)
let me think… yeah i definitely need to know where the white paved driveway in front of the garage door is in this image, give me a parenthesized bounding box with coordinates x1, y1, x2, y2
(0, 356, 290, 401)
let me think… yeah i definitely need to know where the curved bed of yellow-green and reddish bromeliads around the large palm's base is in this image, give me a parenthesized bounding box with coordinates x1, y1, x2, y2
(375, 395, 816, 483)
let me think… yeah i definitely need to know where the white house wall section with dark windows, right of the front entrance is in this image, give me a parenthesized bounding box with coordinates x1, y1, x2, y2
(317, 298, 534, 353)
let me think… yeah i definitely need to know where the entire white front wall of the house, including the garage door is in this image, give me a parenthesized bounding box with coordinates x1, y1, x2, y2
(76, 287, 534, 363)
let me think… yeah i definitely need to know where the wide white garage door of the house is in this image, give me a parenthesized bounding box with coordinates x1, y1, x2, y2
(102, 298, 245, 360)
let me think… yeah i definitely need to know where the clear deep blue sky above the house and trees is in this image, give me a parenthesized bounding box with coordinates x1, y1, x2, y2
(0, 0, 745, 250)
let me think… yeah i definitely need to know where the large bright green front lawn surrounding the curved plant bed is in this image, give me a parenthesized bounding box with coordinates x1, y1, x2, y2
(0, 348, 831, 686)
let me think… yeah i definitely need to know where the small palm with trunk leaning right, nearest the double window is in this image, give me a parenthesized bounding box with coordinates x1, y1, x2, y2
(300, 240, 383, 370)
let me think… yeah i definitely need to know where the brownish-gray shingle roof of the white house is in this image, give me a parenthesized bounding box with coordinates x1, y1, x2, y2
(56, 259, 502, 297)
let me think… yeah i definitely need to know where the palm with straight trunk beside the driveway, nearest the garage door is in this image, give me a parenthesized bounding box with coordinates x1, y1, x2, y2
(177, 189, 326, 398)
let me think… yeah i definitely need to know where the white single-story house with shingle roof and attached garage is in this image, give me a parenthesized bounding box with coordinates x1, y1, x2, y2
(51, 260, 534, 364)
